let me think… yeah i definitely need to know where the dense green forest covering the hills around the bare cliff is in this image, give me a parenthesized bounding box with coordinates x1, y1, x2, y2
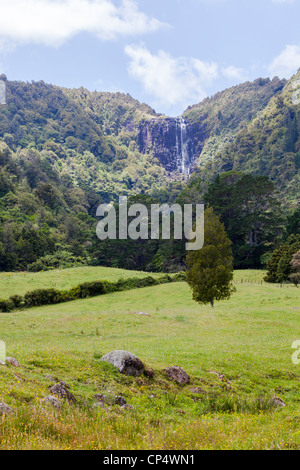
(0, 72, 300, 276)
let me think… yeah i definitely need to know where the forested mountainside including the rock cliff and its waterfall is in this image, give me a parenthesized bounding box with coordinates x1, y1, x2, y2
(0, 72, 300, 270)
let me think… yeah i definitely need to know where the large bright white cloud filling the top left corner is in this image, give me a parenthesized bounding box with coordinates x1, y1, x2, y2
(0, 0, 163, 46)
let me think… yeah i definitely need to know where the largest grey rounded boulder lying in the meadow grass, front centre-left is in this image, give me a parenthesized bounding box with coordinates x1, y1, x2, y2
(101, 351, 145, 377)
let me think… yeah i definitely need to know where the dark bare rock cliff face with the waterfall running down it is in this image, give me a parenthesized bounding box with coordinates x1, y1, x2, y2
(138, 117, 196, 176)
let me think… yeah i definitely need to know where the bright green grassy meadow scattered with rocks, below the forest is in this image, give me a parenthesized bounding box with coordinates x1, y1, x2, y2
(0, 268, 300, 450)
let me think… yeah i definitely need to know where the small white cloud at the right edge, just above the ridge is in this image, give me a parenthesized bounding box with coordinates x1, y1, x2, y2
(268, 45, 300, 78)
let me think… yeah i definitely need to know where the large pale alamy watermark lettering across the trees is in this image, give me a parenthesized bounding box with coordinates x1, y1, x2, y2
(96, 196, 204, 251)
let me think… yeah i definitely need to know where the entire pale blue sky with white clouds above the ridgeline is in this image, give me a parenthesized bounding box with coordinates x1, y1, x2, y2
(0, 0, 300, 116)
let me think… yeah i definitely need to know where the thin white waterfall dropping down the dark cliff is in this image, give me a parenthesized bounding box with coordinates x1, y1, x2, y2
(175, 117, 191, 176)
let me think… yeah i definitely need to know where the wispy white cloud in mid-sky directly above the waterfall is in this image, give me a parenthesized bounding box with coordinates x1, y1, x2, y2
(125, 45, 244, 114)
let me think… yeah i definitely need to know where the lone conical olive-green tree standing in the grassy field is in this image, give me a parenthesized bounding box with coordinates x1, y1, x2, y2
(186, 207, 235, 307)
